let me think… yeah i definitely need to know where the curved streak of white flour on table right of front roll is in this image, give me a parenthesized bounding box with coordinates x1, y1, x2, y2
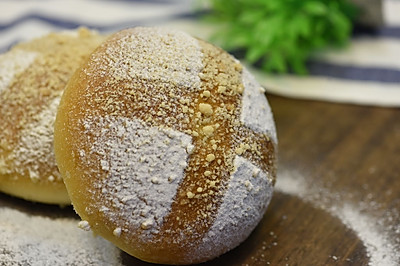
(275, 171, 400, 266)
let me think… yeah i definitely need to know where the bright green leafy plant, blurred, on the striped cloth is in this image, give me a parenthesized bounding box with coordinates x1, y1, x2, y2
(208, 0, 356, 74)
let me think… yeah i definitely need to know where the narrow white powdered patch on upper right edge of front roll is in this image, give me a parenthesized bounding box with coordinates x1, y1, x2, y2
(240, 68, 278, 143)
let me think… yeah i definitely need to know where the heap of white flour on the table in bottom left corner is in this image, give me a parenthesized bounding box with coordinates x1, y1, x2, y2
(0, 207, 122, 266)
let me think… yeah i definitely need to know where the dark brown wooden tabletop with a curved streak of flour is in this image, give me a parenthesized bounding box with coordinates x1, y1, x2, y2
(0, 96, 400, 265)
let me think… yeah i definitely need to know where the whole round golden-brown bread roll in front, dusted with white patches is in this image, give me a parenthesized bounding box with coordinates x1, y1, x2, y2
(55, 27, 277, 264)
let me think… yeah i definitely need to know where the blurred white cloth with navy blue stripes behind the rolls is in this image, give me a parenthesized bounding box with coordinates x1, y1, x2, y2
(0, 0, 400, 107)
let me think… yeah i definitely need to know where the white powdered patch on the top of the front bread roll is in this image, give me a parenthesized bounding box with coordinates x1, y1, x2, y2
(100, 27, 203, 90)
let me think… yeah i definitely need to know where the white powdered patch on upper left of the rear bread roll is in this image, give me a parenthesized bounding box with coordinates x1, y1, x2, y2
(0, 50, 38, 93)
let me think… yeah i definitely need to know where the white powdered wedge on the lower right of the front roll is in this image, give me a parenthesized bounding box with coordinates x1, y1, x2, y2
(199, 156, 273, 260)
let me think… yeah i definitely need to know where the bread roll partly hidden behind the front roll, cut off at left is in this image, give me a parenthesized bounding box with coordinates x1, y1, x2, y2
(0, 28, 105, 205)
